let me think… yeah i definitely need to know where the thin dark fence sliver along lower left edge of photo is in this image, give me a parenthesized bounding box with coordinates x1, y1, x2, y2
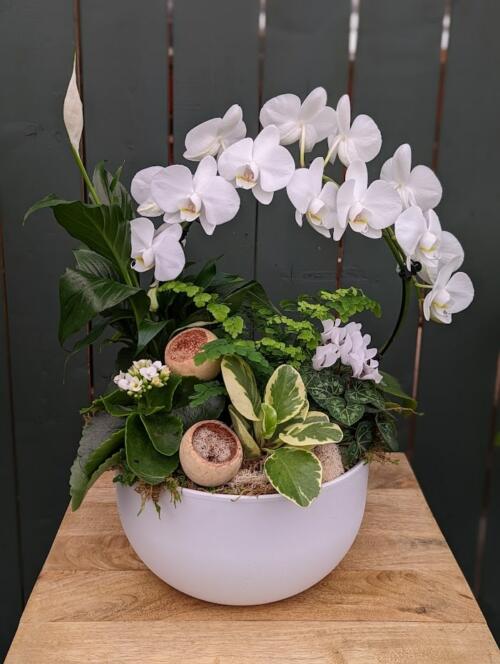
(0, 241, 22, 660)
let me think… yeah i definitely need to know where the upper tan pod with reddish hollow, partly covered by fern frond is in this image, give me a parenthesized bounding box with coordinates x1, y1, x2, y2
(165, 327, 221, 380)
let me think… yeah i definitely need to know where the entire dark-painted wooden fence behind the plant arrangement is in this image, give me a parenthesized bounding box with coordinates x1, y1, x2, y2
(0, 0, 500, 647)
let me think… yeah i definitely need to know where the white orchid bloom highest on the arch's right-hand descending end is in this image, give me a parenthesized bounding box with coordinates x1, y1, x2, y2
(380, 143, 443, 211)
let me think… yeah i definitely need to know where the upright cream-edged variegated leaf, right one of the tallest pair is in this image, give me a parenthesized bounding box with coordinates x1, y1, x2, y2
(264, 364, 306, 424)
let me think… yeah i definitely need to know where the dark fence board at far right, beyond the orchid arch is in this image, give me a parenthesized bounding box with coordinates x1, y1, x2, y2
(415, 0, 500, 579)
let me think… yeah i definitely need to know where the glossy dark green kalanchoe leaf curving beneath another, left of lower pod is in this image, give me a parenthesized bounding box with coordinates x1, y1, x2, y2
(125, 413, 179, 481)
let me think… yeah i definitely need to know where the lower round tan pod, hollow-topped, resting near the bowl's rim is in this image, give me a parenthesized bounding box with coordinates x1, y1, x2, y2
(179, 420, 243, 487)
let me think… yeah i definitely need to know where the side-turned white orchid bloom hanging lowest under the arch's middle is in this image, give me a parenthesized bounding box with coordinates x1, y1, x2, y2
(286, 157, 338, 237)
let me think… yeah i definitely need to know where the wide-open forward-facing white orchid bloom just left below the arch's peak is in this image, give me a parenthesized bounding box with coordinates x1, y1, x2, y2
(219, 125, 295, 205)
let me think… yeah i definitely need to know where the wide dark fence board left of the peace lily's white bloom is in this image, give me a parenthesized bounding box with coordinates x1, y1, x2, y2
(0, 0, 87, 592)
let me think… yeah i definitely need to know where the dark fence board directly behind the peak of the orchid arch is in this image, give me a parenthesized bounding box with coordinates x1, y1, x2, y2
(257, 0, 350, 300)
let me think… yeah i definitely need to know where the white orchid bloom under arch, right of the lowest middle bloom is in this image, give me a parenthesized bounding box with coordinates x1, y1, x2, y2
(333, 161, 401, 240)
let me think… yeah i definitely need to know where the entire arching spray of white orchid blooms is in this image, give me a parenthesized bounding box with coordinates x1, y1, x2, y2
(131, 87, 474, 322)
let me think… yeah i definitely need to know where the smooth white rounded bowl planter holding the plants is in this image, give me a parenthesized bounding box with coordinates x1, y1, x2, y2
(116, 463, 368, 605)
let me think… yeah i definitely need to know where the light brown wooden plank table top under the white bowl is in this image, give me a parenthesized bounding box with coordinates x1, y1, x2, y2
(6, 454, 500, 664)
